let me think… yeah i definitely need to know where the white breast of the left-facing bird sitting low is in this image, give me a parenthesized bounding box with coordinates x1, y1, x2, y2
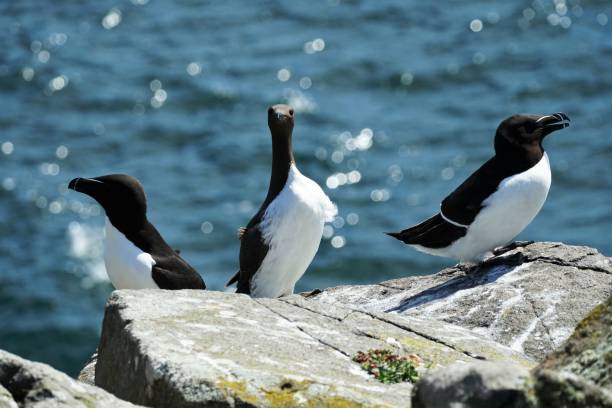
(104, 218, 159, 289)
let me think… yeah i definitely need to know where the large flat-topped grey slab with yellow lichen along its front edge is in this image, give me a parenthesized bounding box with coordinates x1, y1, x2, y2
(95, 290, 534, 407)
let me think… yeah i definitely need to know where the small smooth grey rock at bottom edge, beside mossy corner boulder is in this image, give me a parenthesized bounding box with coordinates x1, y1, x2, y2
(412, 362, 532, 408)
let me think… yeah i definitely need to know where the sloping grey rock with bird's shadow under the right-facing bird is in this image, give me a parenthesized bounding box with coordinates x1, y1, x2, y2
(310, 242, 612, 360)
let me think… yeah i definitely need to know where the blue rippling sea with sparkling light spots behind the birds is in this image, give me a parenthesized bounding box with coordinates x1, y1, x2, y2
(0, 0, 612, 375)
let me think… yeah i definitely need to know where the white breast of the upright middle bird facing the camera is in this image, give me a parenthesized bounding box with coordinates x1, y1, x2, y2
(251, 165, 337, 297)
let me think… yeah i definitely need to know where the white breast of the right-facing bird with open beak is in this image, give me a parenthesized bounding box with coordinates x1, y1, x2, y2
(428, 153, 551, 261)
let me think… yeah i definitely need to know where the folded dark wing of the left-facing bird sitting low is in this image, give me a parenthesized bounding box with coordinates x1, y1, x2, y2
(151, 257, 206, 290)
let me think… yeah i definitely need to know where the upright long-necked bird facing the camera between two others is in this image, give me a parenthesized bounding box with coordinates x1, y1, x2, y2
(227, 105, 337, 297)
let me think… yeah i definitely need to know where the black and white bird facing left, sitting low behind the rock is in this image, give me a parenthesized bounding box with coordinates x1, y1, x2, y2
(68, 174, 206, 289)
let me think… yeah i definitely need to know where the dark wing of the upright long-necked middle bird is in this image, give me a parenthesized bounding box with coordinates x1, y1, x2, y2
(226, 224, 269, 294)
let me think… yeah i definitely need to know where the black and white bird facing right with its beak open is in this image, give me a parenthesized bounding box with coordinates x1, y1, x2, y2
(388, 113, 570, 262)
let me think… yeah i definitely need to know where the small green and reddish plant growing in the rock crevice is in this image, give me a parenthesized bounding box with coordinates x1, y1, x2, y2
(353, 349, 419, 384)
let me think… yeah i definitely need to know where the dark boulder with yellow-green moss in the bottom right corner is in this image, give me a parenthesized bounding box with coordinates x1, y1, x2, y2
(533, 297, 612, 408)
